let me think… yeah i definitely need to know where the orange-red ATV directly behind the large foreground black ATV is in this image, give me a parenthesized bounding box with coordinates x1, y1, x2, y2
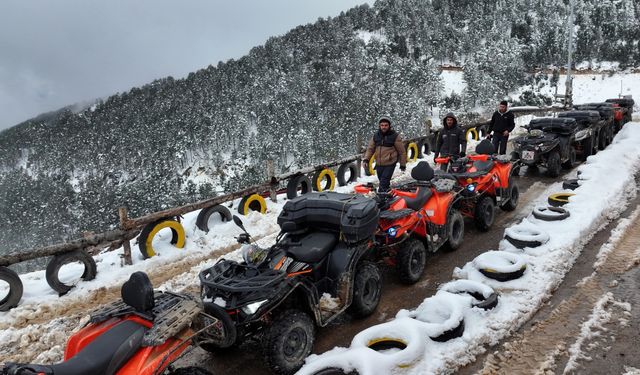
(355, 161, 464, 284)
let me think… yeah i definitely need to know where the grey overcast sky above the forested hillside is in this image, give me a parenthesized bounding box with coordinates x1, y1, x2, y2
(0, 0, 373, 130)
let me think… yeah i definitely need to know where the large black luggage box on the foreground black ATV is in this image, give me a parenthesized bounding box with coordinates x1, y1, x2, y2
(278, 192, 379, 243)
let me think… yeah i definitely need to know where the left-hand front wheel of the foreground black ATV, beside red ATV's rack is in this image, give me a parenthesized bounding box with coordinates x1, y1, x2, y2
(196, 302, 238, 353)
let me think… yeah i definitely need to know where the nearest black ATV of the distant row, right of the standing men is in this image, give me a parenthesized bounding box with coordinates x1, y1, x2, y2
(511, 117, 578, 177)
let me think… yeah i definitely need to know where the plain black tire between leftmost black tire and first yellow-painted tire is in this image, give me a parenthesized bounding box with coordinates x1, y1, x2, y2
(45, 250, 97, 295)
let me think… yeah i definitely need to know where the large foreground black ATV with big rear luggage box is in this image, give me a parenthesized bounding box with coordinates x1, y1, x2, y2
(196, 192, 382, 374)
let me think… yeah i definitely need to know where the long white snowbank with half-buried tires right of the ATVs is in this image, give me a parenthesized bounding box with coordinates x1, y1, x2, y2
(299, 123, 640, 375)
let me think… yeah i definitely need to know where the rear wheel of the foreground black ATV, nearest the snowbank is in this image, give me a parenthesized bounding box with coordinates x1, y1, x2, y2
(349, 261, 382, 318)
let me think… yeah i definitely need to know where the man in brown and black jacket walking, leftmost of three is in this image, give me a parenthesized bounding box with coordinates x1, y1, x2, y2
(362, 116, 407, 193)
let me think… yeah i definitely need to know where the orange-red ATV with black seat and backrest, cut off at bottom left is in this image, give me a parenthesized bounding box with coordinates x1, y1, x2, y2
(0, 272, 213, 375)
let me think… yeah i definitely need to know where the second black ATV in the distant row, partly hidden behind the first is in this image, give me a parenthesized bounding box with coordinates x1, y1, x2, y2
(558, 111, 606, 160)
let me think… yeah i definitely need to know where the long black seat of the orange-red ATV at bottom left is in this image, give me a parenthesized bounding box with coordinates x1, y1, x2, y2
(7, 320, 147, 375)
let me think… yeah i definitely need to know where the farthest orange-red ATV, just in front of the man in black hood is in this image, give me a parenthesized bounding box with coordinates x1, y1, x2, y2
(436, 139, 520, 231)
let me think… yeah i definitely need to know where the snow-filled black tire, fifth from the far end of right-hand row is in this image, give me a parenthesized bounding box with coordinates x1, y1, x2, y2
(473, 251, 527, 281)
